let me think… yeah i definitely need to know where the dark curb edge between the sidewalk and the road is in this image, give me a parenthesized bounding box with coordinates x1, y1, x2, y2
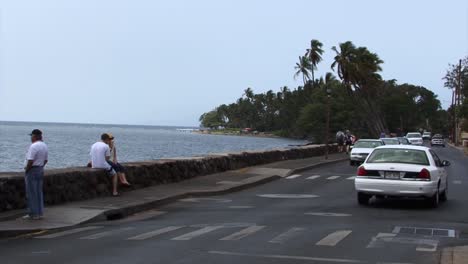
(0, 158, 348, 238)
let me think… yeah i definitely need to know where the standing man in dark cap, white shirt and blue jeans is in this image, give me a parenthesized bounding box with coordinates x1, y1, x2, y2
(23, 129, 49, 220)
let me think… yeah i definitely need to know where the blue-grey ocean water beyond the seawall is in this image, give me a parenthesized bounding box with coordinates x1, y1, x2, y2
(0, 121, 305, 172)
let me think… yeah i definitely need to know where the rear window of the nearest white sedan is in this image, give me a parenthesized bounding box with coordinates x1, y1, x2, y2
(367, 149, 429, 165)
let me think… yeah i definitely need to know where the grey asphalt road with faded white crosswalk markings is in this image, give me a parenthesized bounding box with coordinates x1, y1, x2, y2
(0, 144, 468, 264)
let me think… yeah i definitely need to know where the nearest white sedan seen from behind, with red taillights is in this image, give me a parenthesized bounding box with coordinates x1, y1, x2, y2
(354, 145, 450, 207)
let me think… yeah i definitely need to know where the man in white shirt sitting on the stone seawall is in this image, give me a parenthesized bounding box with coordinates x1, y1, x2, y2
(90, 133, 119, 196)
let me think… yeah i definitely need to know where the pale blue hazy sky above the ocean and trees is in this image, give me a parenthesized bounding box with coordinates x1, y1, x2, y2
(0, 0, 468, 126)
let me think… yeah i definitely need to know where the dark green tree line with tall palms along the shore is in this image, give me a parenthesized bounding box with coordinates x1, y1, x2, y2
(200, 40, 449, 142)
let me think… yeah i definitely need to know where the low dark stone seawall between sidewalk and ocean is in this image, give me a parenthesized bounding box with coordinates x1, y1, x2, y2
(0, 145, 337, 212)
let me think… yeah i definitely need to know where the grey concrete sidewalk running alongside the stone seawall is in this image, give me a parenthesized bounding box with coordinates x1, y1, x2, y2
(0, 154, 348, 237)
